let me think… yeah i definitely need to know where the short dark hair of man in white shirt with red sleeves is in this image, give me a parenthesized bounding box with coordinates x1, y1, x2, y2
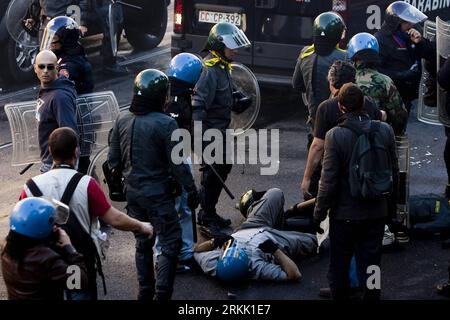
(48, 127, 78, 161)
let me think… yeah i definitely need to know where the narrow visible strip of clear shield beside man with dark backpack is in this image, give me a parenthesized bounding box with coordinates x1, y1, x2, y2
(395, 135, 410, 227)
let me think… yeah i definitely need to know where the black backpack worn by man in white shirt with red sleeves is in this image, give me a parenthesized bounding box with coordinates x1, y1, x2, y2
(26, 172, 106, 295)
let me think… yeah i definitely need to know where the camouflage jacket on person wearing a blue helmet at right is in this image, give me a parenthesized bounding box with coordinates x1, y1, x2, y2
(356, 65, 408, 135)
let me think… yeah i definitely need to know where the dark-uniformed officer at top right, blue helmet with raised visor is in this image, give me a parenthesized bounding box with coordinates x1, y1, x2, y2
(375, 1, 428, 113)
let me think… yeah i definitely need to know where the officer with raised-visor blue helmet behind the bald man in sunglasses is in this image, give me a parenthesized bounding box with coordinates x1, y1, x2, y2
(41, 16, 94, 95)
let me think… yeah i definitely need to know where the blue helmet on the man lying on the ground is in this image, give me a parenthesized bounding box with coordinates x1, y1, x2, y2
(216, 239, 250, 282)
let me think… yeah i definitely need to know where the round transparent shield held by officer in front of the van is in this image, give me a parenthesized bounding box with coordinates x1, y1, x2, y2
(230, 63, 261, 136)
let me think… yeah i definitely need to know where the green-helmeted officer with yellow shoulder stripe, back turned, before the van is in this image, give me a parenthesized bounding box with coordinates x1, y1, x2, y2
(292, 11, 347, 136)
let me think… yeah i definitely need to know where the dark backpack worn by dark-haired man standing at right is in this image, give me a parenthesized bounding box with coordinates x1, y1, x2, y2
(339, 120, 393, 200)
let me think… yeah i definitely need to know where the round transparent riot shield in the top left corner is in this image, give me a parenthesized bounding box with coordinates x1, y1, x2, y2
(5, 0, 39, 48)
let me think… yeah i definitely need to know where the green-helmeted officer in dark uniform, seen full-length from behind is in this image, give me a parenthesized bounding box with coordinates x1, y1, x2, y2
(108, 69, 198, 300)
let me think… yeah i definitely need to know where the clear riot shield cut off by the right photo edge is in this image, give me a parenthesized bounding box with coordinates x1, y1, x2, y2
(436, 17, 450, 127)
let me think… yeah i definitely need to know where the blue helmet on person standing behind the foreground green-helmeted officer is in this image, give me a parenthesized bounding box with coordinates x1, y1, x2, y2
(167, 52, 203, 85)
